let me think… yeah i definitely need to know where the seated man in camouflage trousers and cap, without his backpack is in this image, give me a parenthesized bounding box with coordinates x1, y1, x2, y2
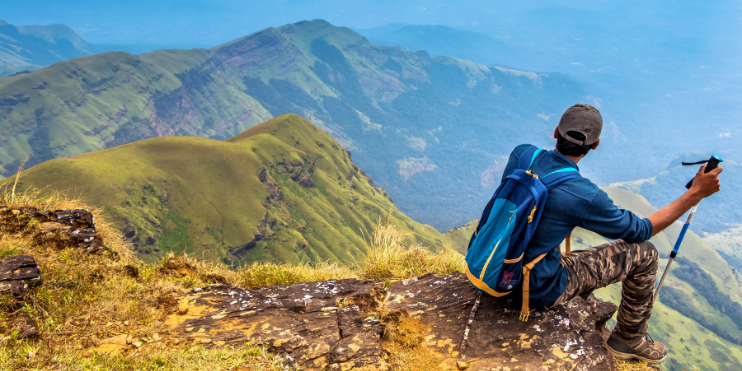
(503, 104, 722, 363)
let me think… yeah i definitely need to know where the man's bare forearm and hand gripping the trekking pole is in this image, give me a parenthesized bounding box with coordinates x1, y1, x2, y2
(648, 165, 724, 236)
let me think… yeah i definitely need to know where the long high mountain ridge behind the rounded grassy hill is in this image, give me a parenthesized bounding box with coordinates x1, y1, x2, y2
(0, 20, 587, 230)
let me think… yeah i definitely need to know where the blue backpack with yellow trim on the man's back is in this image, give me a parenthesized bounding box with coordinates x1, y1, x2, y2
(466, 147, 581, 321)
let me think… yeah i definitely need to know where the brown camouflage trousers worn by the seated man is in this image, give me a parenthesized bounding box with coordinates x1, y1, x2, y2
(554, 240, 658, 339)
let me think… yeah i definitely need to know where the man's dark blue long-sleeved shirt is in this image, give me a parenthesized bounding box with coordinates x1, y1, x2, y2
(503, 144, 652, 306)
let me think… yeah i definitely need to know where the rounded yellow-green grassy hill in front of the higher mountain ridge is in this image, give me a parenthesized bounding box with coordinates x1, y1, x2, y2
(5, 115, 440, 263)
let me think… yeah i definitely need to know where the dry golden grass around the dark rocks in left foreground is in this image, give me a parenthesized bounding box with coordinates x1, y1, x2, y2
(0, 192, 296, 370)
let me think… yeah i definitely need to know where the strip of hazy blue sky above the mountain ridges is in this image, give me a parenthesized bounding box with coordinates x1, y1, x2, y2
(0, 0, 741, 50)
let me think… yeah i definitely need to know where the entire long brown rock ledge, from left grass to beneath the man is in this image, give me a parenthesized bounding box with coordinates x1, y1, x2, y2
(90, 273, 616, 370)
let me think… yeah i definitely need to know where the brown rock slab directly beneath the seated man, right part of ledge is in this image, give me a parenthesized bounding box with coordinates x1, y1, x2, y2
(384, 273, 617, 370)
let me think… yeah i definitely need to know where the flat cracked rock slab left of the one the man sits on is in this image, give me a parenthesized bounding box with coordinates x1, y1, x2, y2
(169, 279, 383, 369)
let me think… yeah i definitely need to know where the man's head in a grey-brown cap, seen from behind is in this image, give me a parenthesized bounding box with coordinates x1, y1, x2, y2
(554, 103, 603, 157)
